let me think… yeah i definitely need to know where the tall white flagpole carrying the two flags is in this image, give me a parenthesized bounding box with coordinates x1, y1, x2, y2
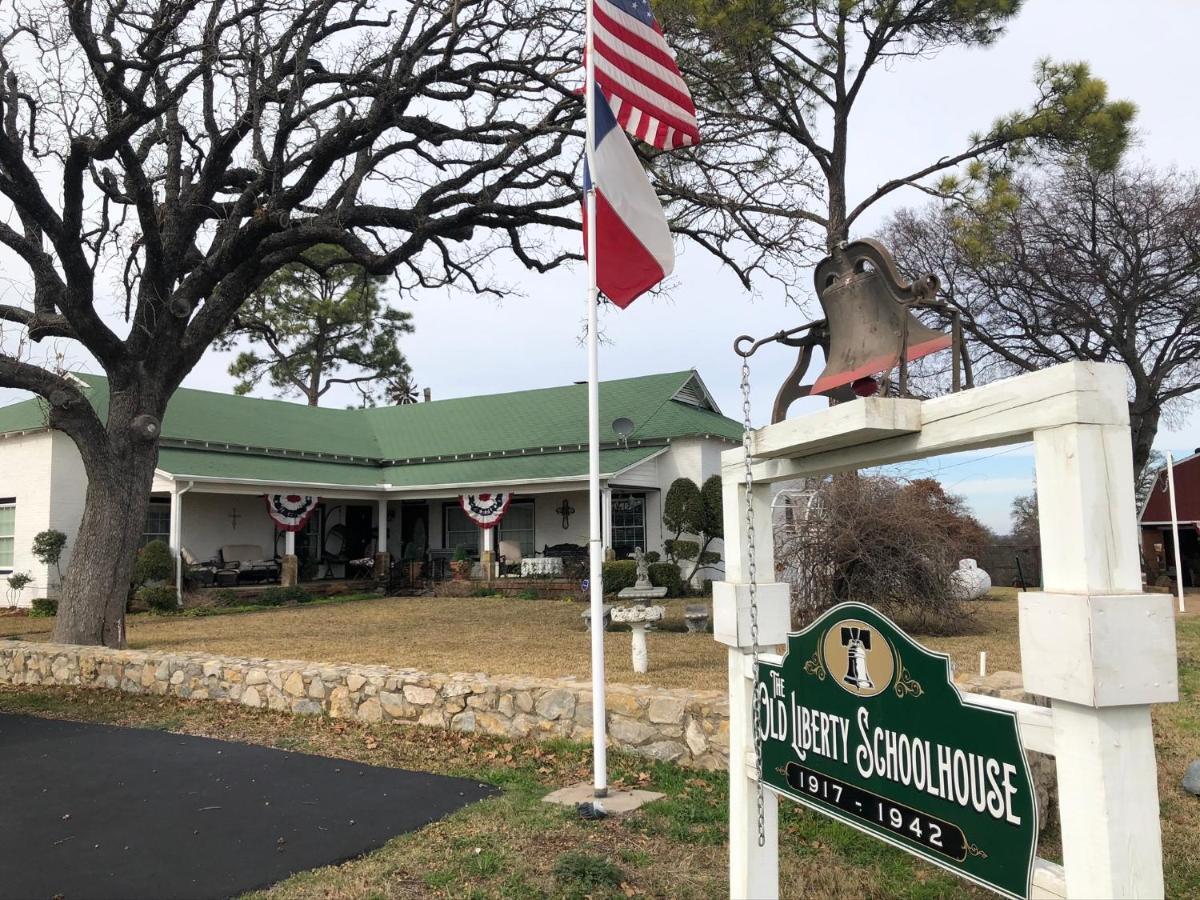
(583, 0, 608, 797)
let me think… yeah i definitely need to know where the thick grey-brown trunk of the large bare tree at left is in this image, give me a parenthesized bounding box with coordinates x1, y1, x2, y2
(54, 428, 158, 647)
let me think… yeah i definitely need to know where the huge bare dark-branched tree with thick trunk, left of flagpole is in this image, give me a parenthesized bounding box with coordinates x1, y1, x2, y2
(0, 0, 580, 644)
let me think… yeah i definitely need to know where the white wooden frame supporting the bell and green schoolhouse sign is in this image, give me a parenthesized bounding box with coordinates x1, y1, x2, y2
(713, 362, 1178, 898)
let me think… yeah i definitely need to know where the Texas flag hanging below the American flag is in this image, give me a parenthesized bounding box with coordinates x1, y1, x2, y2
(583, 86, 674, 310)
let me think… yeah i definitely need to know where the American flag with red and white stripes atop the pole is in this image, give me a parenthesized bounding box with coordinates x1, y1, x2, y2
(592, 0, 700, 150)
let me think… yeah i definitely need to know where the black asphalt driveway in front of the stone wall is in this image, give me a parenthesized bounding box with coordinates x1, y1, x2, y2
(0, 715, 494, 900)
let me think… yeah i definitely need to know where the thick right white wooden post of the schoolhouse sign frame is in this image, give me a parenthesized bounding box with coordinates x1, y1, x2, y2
(1020, 424, 1177, 898)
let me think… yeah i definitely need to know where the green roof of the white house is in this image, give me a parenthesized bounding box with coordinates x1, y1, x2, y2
(0, 371, 742, 487)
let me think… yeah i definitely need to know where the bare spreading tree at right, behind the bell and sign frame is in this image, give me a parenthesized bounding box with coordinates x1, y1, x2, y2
(887, 162, 1200, 472)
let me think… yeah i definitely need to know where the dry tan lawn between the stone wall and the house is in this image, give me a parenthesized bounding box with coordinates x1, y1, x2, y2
(0, 589, 1036, 690)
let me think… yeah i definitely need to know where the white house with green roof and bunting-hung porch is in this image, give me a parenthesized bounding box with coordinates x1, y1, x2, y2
(0, 371, 742, 605)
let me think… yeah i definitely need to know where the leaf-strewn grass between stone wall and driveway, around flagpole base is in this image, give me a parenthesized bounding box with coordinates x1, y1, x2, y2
(0, 688, 983, 900)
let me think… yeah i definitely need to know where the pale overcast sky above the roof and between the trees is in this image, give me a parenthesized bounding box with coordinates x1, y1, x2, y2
(2, 0, 1200, 530)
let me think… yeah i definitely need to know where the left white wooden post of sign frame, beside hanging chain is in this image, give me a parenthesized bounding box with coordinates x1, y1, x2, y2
(713, 472, 790, 900)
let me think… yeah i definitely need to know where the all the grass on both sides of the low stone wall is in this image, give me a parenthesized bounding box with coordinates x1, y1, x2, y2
(0, 590, 1200, 898)
